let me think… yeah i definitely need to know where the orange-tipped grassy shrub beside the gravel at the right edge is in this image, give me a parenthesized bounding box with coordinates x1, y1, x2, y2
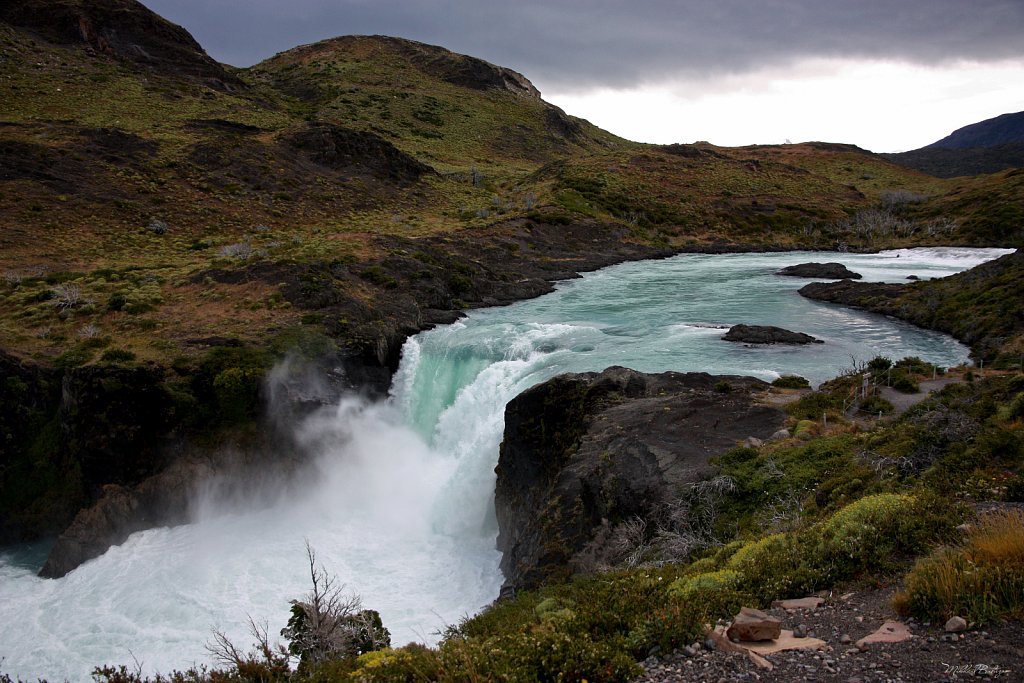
(895, 510, 1024, 625)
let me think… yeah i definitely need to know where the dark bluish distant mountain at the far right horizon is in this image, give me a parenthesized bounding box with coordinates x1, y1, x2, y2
(882, 112, 1024, 178)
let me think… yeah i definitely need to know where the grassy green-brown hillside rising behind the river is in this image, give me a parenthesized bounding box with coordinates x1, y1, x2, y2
(0, 0, 1021, 374)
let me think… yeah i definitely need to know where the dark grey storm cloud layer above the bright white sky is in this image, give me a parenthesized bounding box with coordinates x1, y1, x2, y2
(144, 0, 1024, 89)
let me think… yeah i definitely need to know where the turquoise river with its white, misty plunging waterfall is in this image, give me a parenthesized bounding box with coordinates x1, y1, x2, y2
(0, 249, 1005, 681)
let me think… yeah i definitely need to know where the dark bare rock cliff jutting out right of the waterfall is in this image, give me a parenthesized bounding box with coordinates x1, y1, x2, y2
(496, 368, 784, 589)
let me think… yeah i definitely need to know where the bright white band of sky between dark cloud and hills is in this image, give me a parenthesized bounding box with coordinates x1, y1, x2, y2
(539, 59, 1024, 153)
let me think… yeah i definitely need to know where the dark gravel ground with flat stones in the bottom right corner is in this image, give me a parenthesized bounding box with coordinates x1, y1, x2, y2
(634, 587, 1024, 683)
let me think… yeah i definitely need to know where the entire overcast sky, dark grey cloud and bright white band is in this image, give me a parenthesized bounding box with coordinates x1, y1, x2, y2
(143, 0, 1024, 152)
